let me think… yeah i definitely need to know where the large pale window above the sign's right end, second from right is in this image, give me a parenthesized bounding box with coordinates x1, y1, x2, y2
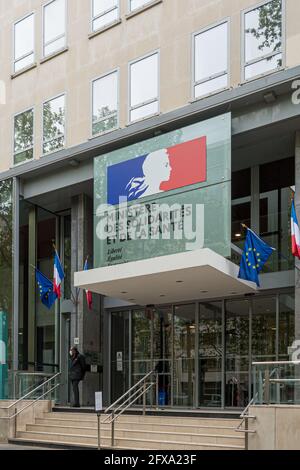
(193, 21, 229, 98)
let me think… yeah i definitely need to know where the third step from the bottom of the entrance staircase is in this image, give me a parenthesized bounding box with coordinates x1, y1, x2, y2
(35, 417, 237, 435)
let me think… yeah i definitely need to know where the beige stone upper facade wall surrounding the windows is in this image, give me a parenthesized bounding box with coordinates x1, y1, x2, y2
(0, 0, 300, 172)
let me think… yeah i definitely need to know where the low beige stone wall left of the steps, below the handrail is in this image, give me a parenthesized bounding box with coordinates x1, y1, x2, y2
(0, 400, 51, 442)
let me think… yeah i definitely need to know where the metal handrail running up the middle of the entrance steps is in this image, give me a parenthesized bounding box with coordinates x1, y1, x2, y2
(103, 370, 158, 447)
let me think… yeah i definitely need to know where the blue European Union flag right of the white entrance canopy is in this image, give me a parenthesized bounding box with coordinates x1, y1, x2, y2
(238, 228, 275, 287)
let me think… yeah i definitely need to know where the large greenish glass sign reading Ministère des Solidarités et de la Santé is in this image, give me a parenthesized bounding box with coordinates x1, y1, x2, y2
(94, 113, 231, 268)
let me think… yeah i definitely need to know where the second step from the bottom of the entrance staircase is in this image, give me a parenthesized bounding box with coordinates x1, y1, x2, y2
(26, 424, 244, 445)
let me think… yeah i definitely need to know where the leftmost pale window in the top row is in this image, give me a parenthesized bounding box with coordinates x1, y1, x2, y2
(14, 13, 34, 73)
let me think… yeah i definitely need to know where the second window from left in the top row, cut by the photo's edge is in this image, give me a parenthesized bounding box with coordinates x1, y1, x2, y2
(43, 0, 66, 57)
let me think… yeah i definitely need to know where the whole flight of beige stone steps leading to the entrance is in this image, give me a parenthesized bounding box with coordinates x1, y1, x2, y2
(10, 412, 245, 450)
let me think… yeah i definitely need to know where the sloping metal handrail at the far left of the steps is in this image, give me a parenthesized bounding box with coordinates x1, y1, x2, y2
(0, 372, 61, 437)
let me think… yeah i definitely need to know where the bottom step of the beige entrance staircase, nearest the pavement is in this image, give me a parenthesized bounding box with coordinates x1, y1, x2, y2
(17, 431, 244, 450)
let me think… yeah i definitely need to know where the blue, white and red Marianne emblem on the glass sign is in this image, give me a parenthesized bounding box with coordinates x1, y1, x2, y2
(107, 137, 207, 205)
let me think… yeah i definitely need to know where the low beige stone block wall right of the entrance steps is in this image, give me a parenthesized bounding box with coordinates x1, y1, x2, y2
(249, 405, 300, 450)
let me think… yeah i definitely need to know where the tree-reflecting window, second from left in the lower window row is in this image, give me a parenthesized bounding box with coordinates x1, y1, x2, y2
(43, 95, 65, 154)
